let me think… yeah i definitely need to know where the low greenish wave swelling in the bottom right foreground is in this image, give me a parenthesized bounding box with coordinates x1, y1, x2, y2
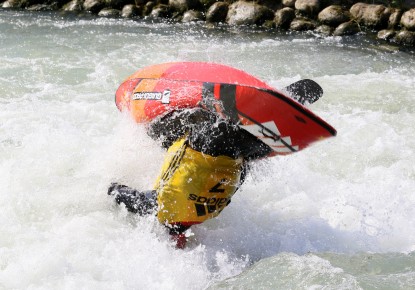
(207, 253, 415, 290)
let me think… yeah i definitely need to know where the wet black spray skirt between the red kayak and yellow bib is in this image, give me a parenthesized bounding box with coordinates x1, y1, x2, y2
(148, 108, 272, 161)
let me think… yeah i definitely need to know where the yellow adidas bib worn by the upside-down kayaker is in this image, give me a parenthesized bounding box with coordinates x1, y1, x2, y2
(155, 138, 242, 225)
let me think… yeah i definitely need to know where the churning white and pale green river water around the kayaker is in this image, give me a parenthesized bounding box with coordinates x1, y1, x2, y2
(0, 10, 415, 289)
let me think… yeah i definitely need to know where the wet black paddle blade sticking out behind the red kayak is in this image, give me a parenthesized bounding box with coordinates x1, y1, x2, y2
(284, 79, 323, 105)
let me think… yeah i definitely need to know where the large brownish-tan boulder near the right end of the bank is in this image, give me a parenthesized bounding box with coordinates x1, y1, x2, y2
(350, 3, 392, 29)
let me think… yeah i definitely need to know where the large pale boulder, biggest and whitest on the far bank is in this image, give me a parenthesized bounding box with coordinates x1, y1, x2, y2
(226, 1, 274, 25)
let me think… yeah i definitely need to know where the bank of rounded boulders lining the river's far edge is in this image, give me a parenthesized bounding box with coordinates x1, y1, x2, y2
(0, 0, 415, 47)
